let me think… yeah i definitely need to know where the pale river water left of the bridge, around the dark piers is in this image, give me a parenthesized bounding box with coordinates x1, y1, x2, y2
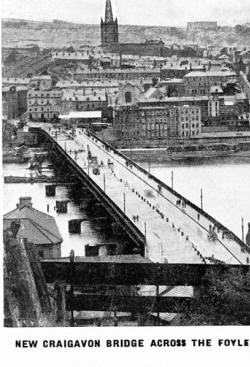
(3, 163, 114, 256)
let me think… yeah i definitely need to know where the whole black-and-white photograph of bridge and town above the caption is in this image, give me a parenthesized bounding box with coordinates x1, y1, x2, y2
(1, 0, 250, 338)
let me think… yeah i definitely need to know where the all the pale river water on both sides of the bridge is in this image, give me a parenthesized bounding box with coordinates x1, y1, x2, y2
(3, 159, 250, 256)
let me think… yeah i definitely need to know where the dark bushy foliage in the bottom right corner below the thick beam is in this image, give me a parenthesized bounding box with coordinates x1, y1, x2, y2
(181, 269, 250, 325)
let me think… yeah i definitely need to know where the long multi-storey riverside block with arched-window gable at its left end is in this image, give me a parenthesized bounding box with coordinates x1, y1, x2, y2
(113, 83, 201, 141)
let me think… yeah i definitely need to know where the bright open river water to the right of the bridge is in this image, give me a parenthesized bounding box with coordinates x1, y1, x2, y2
(144, 158, 250, 238)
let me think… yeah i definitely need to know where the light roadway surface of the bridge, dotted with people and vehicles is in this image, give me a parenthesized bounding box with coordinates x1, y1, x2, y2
(38, 127, 249, 264)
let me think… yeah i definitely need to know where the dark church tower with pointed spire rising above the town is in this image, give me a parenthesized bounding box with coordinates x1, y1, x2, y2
(101, 0, 119, 46)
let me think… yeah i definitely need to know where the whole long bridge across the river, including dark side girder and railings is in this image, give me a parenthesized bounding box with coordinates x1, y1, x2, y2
(30, 124, 250, 265)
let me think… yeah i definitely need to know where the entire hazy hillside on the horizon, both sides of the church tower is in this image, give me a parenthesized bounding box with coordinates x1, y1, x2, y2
(2, 18, 250, 48)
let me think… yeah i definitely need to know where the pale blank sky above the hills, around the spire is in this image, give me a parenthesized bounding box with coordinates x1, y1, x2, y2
(0, 0, 250, 26)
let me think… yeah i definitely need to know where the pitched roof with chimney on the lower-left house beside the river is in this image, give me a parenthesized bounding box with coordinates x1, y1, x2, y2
(3, 198, 63, 245)
